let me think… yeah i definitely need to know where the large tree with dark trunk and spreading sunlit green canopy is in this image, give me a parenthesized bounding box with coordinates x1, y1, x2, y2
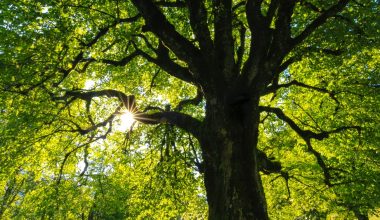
(0, 0, 380, 220)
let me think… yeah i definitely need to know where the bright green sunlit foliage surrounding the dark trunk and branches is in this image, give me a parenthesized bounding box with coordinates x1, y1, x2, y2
(0, 0, 380, 219)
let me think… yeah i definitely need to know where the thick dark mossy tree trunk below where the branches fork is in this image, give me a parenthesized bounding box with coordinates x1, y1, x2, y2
(201, 95, 268, 220)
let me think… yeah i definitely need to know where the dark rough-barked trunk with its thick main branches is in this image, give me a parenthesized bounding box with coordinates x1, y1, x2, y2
(127, 0, 349, 220)
